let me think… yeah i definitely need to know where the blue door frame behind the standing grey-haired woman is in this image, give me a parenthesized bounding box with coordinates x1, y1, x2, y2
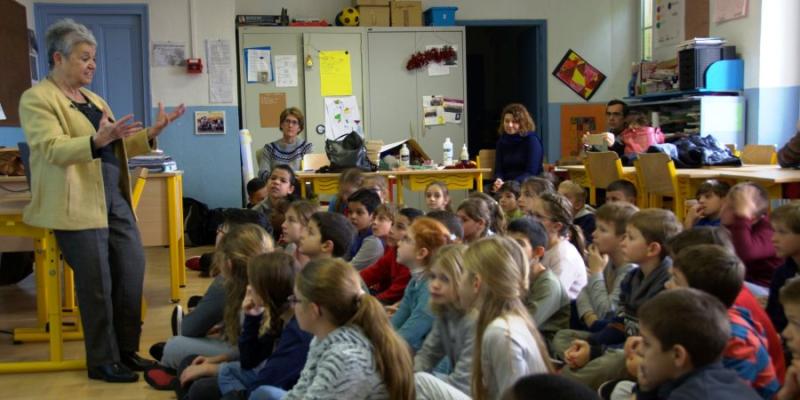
(33, 3, 152, 126)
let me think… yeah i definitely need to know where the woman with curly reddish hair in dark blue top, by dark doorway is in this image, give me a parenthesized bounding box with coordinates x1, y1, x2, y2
(491, 103, 544, 192)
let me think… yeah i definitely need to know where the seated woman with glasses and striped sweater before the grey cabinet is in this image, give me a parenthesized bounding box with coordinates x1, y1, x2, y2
(258, 107, 312, 181)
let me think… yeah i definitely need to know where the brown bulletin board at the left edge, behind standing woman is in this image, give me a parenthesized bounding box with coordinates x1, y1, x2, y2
(0, 0, 31, 126)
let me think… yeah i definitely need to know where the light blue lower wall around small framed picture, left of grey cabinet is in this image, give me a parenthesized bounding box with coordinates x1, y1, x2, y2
(156, 106, 242, 208)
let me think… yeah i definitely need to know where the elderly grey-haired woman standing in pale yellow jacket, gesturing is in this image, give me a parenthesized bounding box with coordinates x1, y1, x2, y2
(20, 19, 185, 382)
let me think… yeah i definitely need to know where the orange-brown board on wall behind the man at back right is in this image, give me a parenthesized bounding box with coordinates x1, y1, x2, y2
(561, 103, 606, 160)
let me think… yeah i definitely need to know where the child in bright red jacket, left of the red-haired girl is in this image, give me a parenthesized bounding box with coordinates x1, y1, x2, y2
(359, 207, 423, 305)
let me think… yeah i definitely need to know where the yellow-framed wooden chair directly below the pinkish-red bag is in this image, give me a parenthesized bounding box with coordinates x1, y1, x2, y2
(633, 153, 685, 217)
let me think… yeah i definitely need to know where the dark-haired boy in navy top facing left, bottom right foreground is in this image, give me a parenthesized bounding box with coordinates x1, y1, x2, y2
(636, 288, 760, 400)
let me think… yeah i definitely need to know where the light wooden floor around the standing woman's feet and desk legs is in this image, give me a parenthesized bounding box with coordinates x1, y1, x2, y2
(0, 247, 211, 400)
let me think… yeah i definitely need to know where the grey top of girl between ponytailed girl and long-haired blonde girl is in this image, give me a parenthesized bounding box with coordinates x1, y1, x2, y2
(414, 310, 478, 395)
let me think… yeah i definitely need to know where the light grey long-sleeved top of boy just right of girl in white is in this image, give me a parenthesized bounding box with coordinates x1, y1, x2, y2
(575, 260, 636, 319)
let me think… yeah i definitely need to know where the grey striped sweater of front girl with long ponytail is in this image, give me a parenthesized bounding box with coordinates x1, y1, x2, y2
(284, 325, 389, 400)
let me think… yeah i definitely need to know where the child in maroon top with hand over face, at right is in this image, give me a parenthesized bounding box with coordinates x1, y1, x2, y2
(720, 182, 782, 297)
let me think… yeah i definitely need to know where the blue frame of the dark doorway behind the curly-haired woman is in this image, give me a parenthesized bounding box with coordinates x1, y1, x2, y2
(456, 19, 560, 154)
